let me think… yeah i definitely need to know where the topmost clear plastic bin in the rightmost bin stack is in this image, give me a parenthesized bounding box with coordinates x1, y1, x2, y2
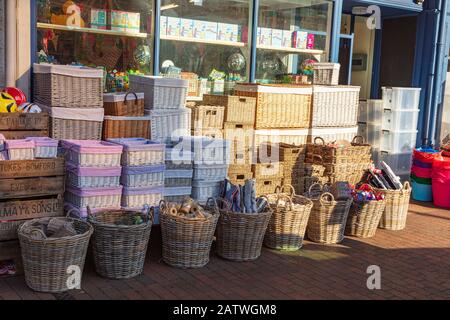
(382, 87, 422, 110)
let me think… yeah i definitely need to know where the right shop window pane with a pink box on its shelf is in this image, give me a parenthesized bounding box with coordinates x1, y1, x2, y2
(256, 0, 333, 83)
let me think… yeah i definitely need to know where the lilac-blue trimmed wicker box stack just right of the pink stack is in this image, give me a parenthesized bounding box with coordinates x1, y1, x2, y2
(109, 138, 166, 210)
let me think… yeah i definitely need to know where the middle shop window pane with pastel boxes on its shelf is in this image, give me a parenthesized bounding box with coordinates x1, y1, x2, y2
(160, 0, 250, 96)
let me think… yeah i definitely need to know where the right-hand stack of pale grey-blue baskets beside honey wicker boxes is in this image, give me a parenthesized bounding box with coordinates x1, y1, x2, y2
(177, 137, 230, 204)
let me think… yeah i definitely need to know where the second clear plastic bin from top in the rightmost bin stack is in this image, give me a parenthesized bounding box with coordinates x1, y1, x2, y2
(383, 109, 420, 131)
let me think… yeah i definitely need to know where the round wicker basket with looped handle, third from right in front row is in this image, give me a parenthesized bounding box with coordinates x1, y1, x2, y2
(307, 193, 353, 244)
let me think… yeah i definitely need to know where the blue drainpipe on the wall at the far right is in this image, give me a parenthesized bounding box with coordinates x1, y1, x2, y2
(429, 0, 448, 145)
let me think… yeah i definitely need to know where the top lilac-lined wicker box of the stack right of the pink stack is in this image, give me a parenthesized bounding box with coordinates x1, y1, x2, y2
(108, 138, 166, 167)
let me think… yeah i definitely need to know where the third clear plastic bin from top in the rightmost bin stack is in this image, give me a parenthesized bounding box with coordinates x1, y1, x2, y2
(381, 130, 418, 153)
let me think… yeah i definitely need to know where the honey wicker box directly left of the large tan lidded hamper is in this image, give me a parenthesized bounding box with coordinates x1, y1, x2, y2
(203, 94, 256, 124)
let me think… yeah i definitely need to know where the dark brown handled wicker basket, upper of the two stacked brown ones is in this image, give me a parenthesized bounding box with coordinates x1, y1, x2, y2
(103, 92, 144, 117)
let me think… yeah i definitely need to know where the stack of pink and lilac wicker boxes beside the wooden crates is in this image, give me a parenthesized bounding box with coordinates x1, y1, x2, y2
(61, 140, 123, 218)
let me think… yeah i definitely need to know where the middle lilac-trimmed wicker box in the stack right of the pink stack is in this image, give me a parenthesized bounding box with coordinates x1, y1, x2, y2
(120, 164, 166, 188)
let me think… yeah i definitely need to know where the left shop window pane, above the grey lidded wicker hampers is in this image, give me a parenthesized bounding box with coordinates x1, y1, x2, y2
(36, 0, 154, 91)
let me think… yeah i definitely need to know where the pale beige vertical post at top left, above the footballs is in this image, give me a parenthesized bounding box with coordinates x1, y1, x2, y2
(5, 0, 17, 87)
